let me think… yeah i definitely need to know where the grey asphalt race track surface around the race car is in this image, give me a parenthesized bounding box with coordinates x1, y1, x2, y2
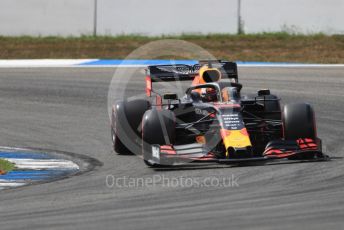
(0, 68, 344, 230)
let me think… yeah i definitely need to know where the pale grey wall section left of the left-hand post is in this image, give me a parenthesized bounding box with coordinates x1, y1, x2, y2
(0, 0, 94, 36)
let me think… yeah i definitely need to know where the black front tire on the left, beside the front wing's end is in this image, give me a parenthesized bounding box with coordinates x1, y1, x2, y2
(142, 108, 176, 167)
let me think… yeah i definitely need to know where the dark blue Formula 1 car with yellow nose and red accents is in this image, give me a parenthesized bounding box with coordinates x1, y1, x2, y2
(111, 61, 326, 167)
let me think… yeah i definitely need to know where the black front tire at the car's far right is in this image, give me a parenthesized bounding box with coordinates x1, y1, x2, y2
(283, 103, 317, 140)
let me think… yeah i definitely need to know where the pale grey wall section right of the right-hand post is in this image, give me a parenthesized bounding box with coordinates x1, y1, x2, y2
(241, 0, 344, 34)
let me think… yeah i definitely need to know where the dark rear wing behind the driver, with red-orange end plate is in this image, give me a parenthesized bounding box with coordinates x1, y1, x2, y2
(146, 60, 238, 96)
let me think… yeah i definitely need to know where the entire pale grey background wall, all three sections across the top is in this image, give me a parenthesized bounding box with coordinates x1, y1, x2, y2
(0, 0, 344, 36)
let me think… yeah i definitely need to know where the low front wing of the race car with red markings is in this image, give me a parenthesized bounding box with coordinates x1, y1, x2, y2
(145, 138, 328, 165)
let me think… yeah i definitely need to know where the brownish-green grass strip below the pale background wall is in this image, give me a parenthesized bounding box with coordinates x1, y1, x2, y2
(0, 32, 344, 63)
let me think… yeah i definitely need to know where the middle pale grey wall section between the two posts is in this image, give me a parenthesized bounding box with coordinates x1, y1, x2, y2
(99, 0, 237, 35)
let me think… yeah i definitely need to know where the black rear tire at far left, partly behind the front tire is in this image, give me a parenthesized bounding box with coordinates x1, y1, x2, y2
(111, 99, 151, 154)
